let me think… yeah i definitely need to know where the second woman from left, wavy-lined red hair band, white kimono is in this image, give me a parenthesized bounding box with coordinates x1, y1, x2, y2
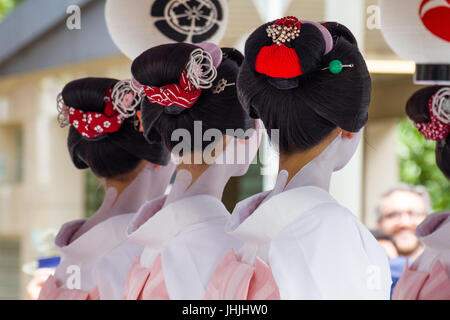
(120, 43, 260, 300)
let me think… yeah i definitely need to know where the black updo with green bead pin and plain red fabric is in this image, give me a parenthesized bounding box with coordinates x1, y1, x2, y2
(237, 17, 371, 153)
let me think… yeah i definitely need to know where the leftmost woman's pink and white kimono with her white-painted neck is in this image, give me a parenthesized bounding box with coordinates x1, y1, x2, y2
(39, 163, 175, 300)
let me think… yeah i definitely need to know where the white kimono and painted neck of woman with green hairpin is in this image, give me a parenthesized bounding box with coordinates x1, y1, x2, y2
(210, 134, 391, 299)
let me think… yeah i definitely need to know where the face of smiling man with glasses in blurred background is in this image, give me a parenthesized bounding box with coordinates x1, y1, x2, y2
(378, 190, 426, 256)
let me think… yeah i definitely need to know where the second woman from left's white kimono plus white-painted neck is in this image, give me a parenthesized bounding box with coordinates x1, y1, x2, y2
(124, 126, 261, 300)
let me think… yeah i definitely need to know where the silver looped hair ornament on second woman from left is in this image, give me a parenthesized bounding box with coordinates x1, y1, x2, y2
(186, 48, 217, 89)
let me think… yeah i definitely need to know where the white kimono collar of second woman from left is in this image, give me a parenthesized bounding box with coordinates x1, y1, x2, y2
(127, 194, 230, 250)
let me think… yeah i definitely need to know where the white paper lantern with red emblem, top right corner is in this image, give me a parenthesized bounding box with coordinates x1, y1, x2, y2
(379, 0, 450, 85)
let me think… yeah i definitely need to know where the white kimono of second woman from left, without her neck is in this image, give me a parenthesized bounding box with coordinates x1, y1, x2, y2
(125, 194, 243, 300)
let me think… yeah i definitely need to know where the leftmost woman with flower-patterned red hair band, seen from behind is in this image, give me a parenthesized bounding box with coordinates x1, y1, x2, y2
(40, 78, 175, 300)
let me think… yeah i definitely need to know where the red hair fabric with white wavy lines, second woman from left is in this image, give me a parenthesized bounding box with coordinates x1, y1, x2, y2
(143, 71, 202, 108)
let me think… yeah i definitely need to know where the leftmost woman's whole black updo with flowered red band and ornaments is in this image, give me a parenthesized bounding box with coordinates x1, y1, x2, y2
(58, 78, 170, 178)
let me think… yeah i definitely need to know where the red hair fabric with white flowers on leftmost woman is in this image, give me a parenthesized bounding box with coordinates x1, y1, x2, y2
(67, 88, 125, 139)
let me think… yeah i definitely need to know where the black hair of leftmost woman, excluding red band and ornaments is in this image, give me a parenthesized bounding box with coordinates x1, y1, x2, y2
(62, 78, 170, 178)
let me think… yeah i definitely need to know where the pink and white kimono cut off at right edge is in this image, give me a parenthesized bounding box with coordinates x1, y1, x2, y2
(392, 212, 450, 300)
